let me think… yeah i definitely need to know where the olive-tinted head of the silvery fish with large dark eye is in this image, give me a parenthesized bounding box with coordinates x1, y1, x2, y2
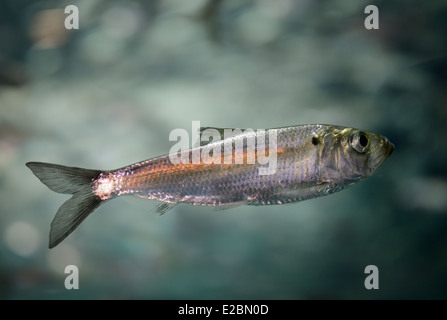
(320, 126, 394, 186)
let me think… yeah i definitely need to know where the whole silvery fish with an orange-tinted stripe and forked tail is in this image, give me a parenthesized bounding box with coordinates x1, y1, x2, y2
(26, 124, 394, 248)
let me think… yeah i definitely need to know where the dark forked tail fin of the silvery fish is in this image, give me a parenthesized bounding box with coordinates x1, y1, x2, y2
(26, 162, 101, 248)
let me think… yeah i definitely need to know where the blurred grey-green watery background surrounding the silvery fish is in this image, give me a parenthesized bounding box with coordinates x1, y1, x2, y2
(0, 0, 447, 299)
